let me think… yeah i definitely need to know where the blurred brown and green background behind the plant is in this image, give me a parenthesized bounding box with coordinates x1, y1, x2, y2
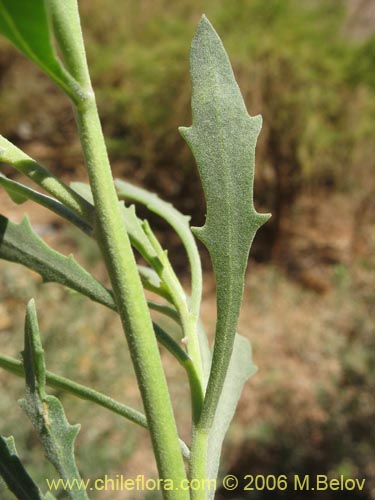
(0, 0, 375, 500)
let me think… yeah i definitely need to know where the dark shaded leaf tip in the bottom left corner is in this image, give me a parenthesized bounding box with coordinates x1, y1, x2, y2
(0, 436, 44, 500)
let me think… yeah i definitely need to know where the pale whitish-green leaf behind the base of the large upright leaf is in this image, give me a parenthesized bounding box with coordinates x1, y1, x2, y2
(206, 334, 257, 499)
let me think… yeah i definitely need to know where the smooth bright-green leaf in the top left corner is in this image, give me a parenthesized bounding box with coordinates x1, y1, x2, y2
(0, 0, 74, 97)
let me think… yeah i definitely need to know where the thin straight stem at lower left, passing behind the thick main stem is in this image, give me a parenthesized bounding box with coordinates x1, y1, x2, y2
(0, 354, 190, 458)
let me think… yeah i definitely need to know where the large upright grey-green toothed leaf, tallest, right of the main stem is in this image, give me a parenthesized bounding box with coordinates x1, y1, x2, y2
(180, 16, 269, 429)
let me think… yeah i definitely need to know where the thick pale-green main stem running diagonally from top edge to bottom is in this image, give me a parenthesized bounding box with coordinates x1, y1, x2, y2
(49, 0, 190, 492)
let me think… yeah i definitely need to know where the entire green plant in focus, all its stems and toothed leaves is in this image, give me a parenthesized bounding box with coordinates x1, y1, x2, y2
(0, 4, 269, 500)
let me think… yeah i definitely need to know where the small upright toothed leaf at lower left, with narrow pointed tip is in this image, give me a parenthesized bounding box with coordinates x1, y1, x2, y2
(19, 300, 88, 500)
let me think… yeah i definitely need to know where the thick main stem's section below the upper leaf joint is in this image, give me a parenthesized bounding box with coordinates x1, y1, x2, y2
(77, 97, 189, 499)
